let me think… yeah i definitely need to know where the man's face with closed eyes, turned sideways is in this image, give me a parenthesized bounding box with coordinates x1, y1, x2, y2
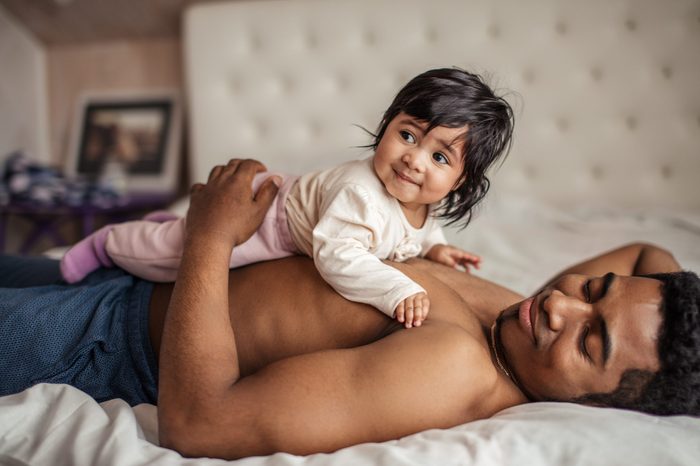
(498, 274, 662, 400)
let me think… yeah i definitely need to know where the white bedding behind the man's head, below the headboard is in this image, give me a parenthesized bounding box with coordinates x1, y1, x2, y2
(447, 195, 700, 295)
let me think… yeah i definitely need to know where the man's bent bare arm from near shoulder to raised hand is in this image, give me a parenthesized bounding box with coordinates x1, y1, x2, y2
(158, 162, 497, 458)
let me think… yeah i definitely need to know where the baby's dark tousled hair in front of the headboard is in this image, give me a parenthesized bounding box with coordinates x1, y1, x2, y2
(369, 68, 514, 228)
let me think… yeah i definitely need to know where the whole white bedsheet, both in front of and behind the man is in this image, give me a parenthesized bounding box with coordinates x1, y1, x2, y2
(0, 197, 700, 466)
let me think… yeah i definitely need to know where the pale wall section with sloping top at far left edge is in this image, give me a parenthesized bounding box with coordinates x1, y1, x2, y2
(0, 6, 51, 161)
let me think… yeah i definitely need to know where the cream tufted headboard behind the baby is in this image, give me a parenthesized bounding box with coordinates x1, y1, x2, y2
(184, 0, 700, 210)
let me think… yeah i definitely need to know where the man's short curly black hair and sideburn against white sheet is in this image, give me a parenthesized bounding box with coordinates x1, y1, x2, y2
(572, 272, 700, 416)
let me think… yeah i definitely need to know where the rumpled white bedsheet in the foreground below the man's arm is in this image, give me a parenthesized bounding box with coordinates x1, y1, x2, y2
(0, 384, 700, 466)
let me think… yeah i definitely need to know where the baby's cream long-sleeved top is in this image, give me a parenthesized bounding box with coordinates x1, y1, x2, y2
(286, 157, 446, 317)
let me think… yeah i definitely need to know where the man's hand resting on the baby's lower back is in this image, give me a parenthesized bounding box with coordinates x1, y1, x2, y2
(186, 159, 281, 246)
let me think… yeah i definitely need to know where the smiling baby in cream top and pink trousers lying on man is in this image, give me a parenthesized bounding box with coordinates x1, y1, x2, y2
(61, 68, 513, 328)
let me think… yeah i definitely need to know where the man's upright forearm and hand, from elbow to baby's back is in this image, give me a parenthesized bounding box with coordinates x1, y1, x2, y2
(158, 161, 276, 456)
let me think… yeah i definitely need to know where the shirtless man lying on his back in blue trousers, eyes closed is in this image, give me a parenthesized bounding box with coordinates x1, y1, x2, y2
(0, 161, 700, 458)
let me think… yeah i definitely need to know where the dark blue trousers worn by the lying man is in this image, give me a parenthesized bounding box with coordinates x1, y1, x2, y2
(0, 255, 158, 405)
